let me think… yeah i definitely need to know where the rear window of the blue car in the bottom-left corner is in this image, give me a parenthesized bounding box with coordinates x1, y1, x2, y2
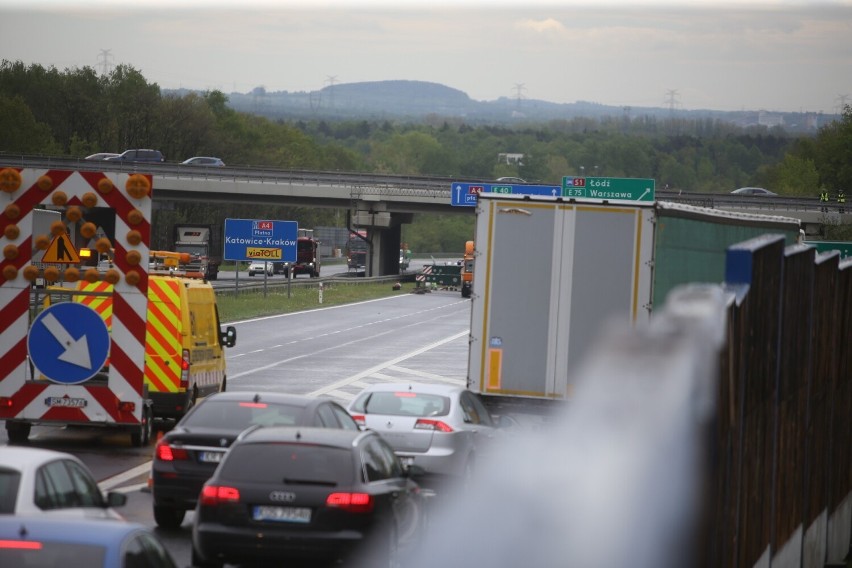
(0, 539, 106, 568)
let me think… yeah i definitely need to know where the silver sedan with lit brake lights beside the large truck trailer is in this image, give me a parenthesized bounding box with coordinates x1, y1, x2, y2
(349, 383, 499, 477)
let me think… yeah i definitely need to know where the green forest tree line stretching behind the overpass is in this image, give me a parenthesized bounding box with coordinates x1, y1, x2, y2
(0, 60, 852, 252)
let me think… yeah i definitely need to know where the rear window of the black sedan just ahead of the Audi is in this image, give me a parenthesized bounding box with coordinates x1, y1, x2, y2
(182, 400, 304, 430)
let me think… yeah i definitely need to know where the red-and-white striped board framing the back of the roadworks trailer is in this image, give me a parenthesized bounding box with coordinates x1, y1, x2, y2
(0, 169, 151, 424)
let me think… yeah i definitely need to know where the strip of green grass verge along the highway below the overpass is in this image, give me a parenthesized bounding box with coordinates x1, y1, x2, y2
(216, 282, 414, 323)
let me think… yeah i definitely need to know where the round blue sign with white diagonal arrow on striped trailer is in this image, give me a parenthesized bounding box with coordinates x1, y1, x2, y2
(27, 302, 110, 385)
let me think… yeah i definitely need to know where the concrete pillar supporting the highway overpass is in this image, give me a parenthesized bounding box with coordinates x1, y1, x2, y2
(351, 202, 414, 276)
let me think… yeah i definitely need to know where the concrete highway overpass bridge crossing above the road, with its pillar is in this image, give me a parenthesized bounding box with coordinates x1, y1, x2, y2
(0, 155, 852, 275)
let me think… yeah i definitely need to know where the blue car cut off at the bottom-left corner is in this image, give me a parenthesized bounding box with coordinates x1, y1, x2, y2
(0, 515, 177, 568)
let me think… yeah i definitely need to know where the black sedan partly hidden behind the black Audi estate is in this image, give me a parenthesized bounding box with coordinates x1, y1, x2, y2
(151, 391, 359, 529)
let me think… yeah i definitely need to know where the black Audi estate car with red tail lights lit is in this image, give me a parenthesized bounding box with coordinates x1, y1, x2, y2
(192, 427, 422, 567)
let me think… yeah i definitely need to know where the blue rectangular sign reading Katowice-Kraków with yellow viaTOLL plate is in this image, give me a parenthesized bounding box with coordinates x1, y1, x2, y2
(224, 219, 299, 262)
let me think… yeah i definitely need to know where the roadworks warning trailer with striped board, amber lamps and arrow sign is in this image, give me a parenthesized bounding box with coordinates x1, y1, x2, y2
(0, 166, 152, 445)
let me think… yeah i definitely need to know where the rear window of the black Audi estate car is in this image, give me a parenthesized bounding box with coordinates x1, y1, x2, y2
(219, 442, 355, 487)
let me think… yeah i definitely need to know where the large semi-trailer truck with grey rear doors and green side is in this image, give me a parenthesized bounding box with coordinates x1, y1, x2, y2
(467, 193, 801, 414)
